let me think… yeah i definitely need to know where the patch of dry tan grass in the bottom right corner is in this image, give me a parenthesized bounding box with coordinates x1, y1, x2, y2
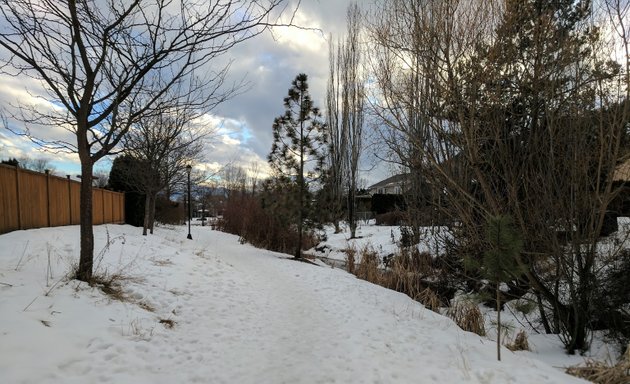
(567, 346, 630, 384)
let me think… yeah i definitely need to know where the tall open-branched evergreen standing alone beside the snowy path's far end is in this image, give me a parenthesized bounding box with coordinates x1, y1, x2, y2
(268, 73, 327, 258)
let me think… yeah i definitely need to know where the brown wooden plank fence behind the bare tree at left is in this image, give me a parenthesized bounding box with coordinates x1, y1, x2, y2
(0, 164, 125, 233)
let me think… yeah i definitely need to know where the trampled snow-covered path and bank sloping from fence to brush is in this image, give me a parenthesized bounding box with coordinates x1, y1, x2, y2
(0, 225, 582, 384)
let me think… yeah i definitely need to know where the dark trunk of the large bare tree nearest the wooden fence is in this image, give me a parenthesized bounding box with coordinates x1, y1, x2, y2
(76, 158, 94, 282)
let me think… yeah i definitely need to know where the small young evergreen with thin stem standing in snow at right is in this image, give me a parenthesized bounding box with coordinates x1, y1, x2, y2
(482, 216, 523, 360)
